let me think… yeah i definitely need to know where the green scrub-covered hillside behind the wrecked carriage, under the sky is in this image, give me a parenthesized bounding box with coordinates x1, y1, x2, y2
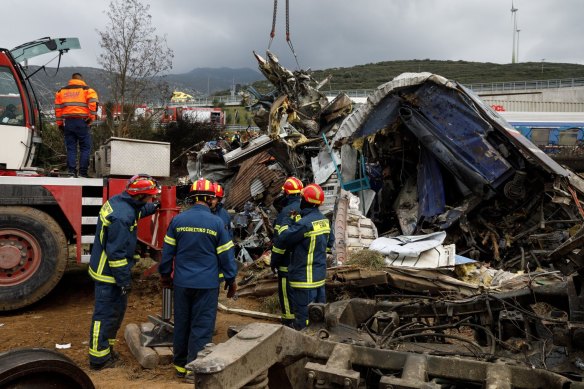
(252, 59, 584, 93)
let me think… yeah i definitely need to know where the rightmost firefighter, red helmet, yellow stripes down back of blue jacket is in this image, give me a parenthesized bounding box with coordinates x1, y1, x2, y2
(272, 184, 334, 330)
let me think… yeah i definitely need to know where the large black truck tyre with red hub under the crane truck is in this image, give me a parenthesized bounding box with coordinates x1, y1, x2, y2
(0, 206, 67, 311)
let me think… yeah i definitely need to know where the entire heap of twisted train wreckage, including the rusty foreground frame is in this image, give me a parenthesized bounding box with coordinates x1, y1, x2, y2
(185, 52, 584, 388)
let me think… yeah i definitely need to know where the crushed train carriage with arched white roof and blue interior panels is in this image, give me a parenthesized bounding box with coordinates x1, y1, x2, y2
(332, 73, 584, 267)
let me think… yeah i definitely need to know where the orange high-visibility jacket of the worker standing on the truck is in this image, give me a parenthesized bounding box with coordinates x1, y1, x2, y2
(55, 79, 98, 126)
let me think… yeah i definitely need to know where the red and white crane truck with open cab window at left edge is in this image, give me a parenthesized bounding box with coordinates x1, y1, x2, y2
(0, 38, 177, 311)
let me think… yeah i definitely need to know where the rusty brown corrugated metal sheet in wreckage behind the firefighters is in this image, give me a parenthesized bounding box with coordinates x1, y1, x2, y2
(225, 151, 286, 211)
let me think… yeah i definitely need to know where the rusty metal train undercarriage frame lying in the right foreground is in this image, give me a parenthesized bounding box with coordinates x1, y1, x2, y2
(188, 283, 584, 388)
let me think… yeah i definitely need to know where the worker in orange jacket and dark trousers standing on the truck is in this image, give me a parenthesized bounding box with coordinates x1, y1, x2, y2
(55, 73, 98, 177)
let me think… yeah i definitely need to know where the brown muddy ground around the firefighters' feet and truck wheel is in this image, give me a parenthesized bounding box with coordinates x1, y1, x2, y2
(0, 268, 274, 389)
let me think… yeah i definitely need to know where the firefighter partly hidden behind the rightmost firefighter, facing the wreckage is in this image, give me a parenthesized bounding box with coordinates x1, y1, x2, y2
(270, 177, 304, 326)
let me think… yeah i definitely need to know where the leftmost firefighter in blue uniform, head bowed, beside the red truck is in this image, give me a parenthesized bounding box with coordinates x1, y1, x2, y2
(89, 174, 160, 370)
